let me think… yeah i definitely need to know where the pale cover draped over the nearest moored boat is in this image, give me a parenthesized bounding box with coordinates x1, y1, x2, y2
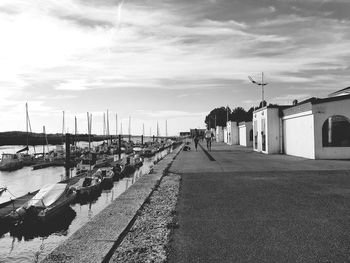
(28, 184, 67, 207)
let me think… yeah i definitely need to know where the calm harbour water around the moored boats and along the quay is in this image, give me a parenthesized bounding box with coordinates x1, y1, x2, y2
(0, 149, 171, 263)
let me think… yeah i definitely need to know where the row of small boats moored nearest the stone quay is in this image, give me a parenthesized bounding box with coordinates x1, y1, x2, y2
(2, 140, 176, 225)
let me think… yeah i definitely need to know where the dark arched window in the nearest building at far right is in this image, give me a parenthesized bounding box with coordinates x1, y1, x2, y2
(322, 115, 350, 147)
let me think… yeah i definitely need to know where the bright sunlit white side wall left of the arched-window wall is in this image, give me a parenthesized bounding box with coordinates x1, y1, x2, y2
(283, 110, 315, 159)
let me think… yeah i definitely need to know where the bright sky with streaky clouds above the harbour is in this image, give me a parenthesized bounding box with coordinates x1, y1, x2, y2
(0, 0, 350, 135)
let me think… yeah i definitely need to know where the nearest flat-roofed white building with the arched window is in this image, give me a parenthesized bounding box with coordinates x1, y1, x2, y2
(282, 95, 350, 159)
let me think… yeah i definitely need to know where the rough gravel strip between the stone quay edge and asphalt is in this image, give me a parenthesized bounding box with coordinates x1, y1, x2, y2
(110, 173, 181, 263)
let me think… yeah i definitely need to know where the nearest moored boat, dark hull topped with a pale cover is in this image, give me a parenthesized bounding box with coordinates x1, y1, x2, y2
(9, 183, 76, 223)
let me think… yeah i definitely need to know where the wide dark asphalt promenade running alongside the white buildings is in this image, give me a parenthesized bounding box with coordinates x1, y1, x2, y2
(169, 143, 350, 263)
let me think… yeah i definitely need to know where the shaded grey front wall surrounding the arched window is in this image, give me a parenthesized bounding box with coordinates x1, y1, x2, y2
(312, 99, 350, 159)
